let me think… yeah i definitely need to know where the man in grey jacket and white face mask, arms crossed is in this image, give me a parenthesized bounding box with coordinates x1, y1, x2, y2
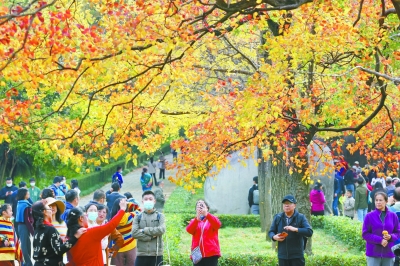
(132, 190, 165, 266)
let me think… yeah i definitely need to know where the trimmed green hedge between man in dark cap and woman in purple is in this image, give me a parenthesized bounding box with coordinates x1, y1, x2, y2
(311, 216, 365, 252)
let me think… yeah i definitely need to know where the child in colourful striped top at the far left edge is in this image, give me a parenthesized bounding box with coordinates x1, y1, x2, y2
(0, 204, 16, 266)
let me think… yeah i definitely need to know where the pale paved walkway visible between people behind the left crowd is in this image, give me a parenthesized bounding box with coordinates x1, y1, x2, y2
(79, 154, 177, 206)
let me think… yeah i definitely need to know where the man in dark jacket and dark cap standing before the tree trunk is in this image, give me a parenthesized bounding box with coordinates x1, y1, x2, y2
(268, 195, 313, 266)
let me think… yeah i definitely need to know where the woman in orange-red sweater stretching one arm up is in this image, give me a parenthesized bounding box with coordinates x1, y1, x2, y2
(67, 199, 126, 266)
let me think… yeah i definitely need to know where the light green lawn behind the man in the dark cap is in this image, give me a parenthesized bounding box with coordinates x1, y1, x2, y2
(178, 227, 363, 256)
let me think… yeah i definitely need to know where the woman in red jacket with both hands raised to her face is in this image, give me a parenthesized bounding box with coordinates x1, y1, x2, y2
(186, 200, 221, 266)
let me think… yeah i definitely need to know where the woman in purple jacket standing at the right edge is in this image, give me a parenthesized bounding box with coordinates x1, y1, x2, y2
(362, 191, 400, 266)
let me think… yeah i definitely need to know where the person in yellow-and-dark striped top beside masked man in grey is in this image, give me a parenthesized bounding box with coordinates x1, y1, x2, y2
(111, 199, 141, 266)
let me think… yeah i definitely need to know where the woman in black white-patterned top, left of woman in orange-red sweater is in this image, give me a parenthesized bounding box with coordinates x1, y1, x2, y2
(32, 200, 86, 266)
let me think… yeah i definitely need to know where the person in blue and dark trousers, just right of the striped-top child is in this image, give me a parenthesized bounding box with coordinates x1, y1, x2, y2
(15, 188, 34, 266)
